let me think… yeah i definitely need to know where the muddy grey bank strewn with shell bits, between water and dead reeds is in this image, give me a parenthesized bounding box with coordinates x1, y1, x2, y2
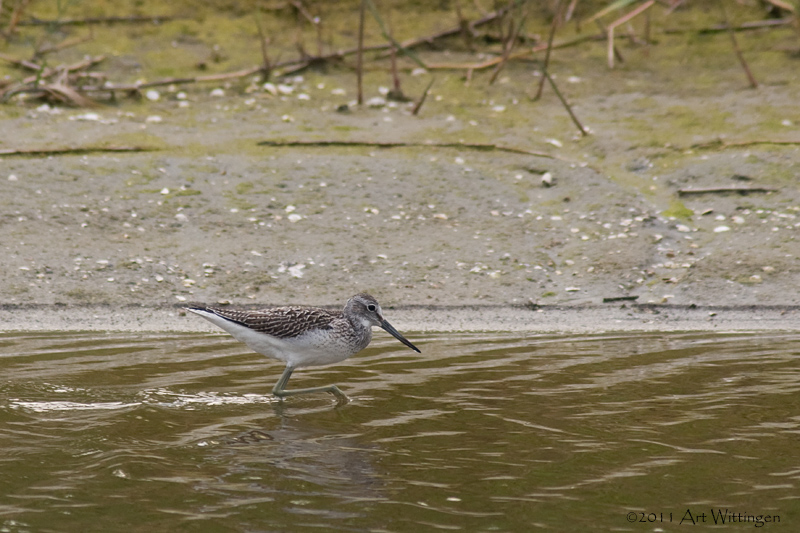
(0, 4, 800, 332)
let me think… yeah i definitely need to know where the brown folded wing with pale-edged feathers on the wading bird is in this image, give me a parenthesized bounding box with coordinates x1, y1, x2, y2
(199, 307, 341, 339)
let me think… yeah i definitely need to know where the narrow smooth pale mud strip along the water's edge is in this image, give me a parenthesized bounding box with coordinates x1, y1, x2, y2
(0, 305, 800, 334)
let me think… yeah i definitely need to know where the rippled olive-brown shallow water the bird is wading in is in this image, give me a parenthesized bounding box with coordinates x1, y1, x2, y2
(0, 333, 800, 532)
